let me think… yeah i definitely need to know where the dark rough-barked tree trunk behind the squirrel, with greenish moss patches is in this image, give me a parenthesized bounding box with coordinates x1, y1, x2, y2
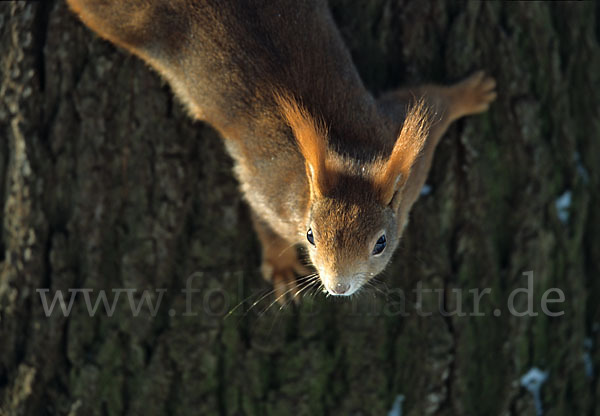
(0, 0, 600, 416)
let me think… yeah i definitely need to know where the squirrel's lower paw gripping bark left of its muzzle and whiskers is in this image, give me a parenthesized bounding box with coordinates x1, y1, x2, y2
(261, 251, 311, 306)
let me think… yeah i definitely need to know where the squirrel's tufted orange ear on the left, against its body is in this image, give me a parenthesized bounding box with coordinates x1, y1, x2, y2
(275, 94, 333, 197)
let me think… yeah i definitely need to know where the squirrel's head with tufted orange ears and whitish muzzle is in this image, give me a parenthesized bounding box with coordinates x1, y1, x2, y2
(277, 93, 429, 296)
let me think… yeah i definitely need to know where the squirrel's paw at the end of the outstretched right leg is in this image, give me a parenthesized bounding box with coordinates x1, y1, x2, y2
(451, 71, 497, 116)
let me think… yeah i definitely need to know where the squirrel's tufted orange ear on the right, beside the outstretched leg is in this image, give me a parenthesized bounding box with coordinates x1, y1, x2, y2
(374, 100, 430, 205)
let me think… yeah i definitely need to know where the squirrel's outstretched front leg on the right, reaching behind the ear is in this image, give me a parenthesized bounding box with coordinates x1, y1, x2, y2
(378, 71, 496, 226)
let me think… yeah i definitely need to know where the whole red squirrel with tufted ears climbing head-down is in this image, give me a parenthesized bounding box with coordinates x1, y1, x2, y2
(67, 0, 496, 303)
